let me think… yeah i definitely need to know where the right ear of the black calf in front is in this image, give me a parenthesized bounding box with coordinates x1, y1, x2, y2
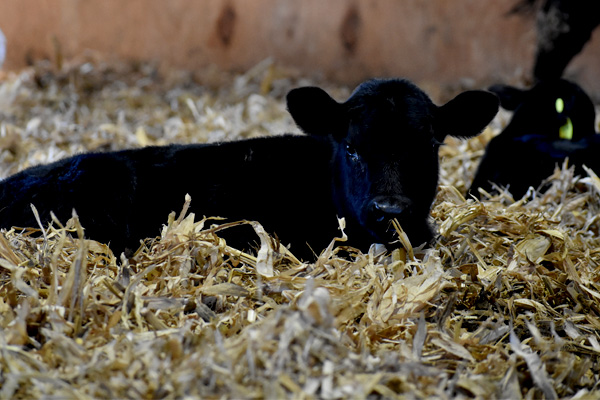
(434, 90, 500, 141)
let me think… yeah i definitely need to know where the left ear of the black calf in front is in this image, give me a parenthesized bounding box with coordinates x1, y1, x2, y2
(287, 87, 348, 137)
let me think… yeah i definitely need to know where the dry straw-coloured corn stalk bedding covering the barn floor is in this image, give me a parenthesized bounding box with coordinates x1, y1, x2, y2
(0, 58, 600, 399)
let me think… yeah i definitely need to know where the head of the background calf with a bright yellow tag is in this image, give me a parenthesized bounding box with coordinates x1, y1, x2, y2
(489, 79, 596, 141)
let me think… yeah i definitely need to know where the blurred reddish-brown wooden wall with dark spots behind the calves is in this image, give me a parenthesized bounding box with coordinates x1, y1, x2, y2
(0, 0, 600, 97)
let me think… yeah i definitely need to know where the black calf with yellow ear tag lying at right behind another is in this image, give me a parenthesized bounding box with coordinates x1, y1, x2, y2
(470, 79, 600, 198)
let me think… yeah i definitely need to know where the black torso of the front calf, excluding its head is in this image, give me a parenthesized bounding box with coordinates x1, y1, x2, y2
(0, 136, 336, 255)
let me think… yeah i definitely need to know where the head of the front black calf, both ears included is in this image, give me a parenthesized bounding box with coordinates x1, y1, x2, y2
(287, 79, 498, 244)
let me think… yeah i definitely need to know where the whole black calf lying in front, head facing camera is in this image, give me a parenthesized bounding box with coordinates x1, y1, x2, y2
(0, 80, 498, 258)
